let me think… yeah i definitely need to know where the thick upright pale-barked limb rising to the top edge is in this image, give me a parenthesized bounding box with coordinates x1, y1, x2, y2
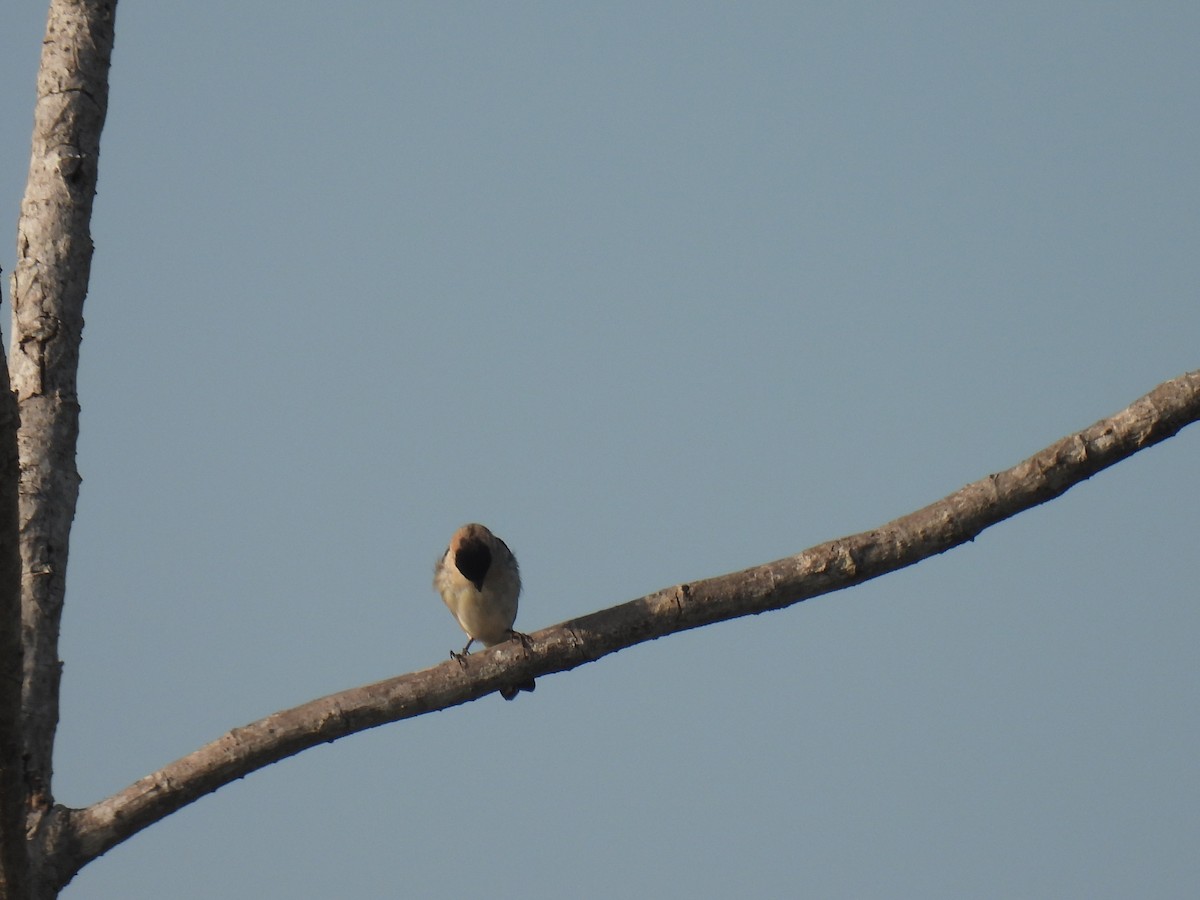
(10, 0, 116, 844)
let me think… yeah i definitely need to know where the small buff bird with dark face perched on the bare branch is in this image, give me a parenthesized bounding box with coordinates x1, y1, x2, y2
(433, 522, 535, 700)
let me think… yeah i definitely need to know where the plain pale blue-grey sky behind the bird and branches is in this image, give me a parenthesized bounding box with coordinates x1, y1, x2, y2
(0, 0, 1200, 900)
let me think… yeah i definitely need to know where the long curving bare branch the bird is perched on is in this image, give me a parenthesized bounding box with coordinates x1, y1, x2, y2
(39, 371, 1200, 892)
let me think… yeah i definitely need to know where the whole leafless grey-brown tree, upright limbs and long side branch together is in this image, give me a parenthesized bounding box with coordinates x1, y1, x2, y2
(0, 0, 1200, 899)
